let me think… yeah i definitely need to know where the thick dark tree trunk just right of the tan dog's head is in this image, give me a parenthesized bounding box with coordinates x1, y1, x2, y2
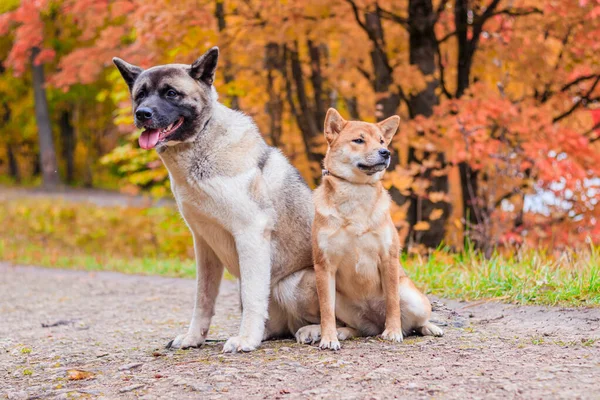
(408, 0, 451, 248)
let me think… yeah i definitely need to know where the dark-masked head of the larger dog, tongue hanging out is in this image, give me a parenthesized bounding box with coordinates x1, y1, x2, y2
(113, 47, 219, 149)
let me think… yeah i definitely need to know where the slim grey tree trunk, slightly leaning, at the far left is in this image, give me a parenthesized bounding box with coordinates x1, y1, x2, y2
(31, 47, 61, 189)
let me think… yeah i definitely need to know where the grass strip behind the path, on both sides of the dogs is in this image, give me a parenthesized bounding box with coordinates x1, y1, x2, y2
(0, 199, 600, 306)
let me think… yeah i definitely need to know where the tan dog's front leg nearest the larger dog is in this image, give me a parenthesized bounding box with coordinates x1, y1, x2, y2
(315, 263, 340, 350)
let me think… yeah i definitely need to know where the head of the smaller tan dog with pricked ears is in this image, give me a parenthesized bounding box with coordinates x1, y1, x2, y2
(324, 108, 400, 183)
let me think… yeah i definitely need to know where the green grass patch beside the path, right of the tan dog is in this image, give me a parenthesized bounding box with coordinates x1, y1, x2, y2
(404, 247, 600, 306)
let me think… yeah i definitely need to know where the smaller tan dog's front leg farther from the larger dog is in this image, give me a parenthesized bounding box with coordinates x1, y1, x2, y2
(381, 245, 403, 342)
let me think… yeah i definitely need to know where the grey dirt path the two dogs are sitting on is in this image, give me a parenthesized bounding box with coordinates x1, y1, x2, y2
(0, 263, 600, 399)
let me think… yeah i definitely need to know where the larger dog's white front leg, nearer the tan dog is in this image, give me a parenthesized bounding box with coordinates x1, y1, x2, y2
(223, 222, 272, 353)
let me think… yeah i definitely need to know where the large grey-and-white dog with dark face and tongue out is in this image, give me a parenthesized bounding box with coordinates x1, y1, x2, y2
(113, 47, 319, 352)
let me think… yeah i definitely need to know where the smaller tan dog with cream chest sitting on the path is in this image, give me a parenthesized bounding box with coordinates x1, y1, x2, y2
(296, 108, 443, 350)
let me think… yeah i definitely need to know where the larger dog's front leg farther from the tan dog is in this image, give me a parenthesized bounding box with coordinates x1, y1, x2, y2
(167, 234, 223, 349)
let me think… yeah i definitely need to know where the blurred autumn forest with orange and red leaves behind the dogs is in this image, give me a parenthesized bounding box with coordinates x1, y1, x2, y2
(0, 0, 600, 256)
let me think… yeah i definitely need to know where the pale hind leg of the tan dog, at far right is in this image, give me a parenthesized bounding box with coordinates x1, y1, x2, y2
(400, 276, 444, 336)
